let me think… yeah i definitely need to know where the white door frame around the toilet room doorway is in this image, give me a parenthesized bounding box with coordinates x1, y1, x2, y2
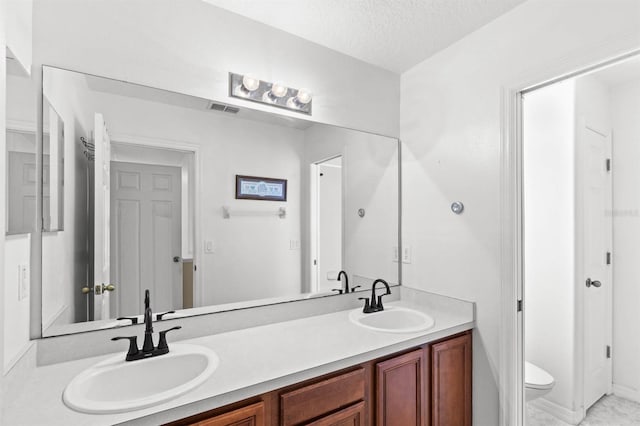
(498, 48, 640, 426)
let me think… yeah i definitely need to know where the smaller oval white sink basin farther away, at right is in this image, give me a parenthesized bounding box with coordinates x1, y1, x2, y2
(349, 306, 435, 333)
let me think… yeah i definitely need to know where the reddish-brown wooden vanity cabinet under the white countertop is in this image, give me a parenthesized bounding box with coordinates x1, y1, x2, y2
(170, 331, 472, 426)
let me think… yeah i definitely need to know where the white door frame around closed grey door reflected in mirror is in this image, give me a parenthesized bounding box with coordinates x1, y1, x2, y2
(111, 133, 201, 307)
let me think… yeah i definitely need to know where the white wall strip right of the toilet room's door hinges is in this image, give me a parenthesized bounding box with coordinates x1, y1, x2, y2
(611, 78, 640, 402)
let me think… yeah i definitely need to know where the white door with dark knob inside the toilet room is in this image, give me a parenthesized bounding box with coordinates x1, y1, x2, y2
(578, 124, 613, 411)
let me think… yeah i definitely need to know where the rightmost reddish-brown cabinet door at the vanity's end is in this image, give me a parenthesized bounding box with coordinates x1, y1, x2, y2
(431, 334, 472, 426)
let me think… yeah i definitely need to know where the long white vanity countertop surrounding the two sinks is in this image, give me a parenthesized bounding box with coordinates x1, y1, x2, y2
(4, 292, 474, 426)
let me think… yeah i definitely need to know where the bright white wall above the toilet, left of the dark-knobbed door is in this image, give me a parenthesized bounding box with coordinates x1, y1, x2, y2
(523, 80, 576, 410)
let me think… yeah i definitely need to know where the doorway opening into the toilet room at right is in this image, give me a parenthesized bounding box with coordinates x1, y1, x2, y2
(516, 57, 640, 426)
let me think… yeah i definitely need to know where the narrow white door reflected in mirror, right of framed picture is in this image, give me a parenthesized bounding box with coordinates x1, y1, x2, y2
(312, 156, 342, 292)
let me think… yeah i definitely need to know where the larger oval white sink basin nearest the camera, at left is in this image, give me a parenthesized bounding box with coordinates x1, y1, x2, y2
(62, 343, 220, 413)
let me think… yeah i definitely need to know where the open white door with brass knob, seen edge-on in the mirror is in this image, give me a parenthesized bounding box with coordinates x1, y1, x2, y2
(93, 113, 112, 320)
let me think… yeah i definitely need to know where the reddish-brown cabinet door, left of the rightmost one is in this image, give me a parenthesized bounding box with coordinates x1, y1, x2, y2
(376, 349, 428, 426)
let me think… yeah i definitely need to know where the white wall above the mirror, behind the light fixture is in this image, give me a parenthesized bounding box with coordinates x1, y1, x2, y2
(33, 0, 399, 136)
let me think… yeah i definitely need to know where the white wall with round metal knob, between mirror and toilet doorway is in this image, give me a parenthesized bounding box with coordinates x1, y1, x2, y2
(400, 0, 640, 425)
